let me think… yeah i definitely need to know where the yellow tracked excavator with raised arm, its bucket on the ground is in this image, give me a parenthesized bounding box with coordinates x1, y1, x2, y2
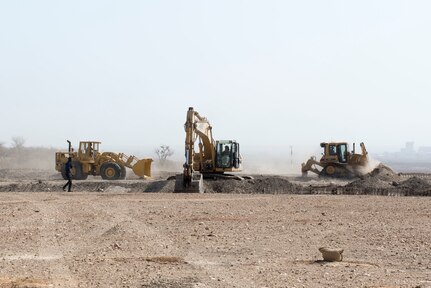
(175, 107, 242, 193)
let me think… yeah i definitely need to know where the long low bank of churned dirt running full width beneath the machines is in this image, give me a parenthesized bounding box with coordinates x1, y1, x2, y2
(0, 164, 431, 196)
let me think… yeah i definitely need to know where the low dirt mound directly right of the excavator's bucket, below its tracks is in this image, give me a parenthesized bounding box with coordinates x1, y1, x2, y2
(204, 176, 301, 194)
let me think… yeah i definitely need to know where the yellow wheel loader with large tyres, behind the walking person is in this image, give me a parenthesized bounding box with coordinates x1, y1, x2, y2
(55, 140, 153, 180)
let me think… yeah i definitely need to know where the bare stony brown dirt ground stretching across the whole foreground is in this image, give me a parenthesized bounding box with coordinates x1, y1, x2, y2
(0, 169, 431, 288)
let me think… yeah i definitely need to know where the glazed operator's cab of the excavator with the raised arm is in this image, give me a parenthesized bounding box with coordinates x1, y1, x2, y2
(216, 140, 241, 169)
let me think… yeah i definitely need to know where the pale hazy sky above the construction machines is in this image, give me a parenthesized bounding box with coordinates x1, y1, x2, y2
(0, 0, 431, 155)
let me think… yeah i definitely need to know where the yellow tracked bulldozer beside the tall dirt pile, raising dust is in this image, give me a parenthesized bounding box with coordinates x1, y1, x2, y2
(301, 142, 368, 178)
